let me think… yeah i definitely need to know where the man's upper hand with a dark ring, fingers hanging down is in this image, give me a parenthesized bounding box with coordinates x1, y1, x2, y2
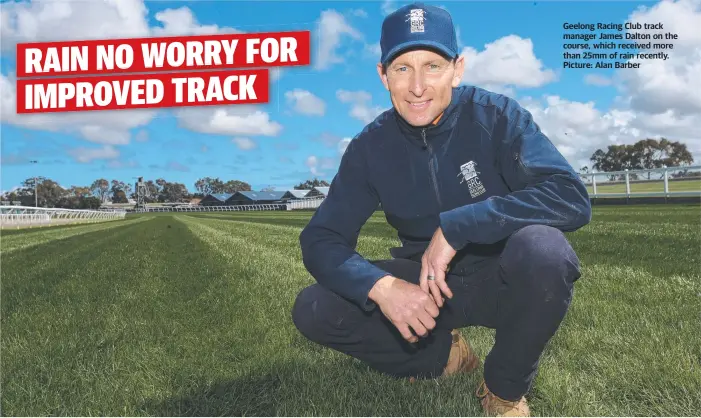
(419, 227, 456, 307)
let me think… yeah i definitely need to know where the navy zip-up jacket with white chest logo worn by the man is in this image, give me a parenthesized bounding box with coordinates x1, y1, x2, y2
(300, 86, 591, 310)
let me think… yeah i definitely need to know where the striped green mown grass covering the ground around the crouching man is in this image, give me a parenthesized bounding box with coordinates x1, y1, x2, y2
(1, 205, 701, 416)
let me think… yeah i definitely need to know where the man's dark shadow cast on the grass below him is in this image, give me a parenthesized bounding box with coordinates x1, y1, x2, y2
(137, 330, 480, 416)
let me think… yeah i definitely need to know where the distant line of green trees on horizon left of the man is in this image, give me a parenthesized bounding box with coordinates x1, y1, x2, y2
(1, 177, 329, 209)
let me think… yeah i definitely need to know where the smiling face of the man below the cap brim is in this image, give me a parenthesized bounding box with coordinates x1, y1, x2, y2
(377, 50, 464, 126)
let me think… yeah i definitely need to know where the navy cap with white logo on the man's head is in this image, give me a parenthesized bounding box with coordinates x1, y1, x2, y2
(380, 3, 458, 65)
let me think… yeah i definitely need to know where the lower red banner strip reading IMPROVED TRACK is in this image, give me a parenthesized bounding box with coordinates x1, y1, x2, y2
(17, 69, 269, 113)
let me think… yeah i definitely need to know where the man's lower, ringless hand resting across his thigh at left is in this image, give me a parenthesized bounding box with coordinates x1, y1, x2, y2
(368, 276, 438, 343)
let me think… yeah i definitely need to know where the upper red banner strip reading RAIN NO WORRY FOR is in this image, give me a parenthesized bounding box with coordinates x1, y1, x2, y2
(17, 31, 311, 78)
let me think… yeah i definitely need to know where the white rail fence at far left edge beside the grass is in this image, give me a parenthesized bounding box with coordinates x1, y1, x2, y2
(0, 206, 126, 228)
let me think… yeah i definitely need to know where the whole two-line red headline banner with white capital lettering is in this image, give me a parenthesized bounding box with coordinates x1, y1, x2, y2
(17, 31, 311, 114)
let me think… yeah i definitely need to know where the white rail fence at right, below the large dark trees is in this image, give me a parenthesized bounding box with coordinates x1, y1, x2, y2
(580, 165, 701, 198)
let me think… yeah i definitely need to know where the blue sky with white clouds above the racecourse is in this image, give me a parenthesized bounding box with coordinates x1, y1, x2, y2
(0, 0, 701, 192)
